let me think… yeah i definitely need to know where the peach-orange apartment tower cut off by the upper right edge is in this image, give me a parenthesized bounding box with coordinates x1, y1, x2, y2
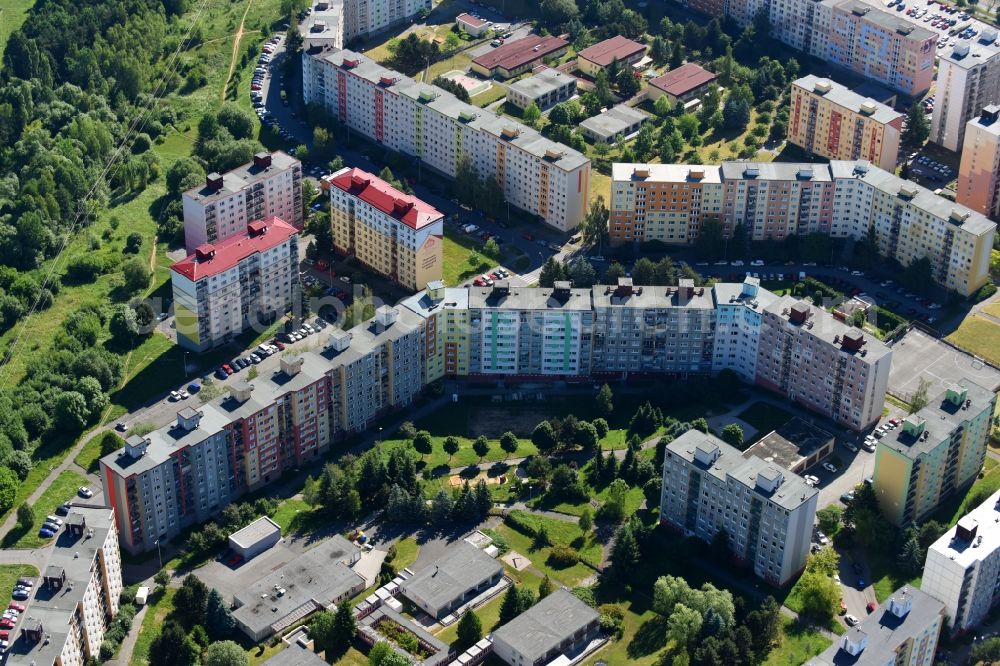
(955, 104, 1000, 220)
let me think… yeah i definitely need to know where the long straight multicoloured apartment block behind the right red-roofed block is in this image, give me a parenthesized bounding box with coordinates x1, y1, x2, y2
(303, 49, 590, 231)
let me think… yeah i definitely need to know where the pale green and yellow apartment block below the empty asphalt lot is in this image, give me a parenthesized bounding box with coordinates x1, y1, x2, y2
(874, 379, 996, 526)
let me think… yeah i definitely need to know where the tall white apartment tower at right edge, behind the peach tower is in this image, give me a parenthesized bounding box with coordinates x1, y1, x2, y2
(930, 28, 1000, 152)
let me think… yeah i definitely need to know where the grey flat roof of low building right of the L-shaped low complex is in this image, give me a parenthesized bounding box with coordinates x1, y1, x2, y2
(401, 541, 503, 608)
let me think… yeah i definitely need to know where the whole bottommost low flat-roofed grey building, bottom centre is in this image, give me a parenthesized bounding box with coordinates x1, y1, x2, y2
(493, 589, 601, 666)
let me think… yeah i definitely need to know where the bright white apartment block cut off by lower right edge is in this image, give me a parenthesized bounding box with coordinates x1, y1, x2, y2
(920, 491, 1000, 634)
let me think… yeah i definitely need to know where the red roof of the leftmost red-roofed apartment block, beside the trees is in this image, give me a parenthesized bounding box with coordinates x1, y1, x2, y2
(170, 215, 299, 281)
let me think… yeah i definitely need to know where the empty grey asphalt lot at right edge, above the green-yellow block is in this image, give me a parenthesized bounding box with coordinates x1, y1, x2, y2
(889, 328, 1000, 397)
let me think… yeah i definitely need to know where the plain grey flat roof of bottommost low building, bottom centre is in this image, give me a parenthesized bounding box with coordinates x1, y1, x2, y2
(493, 588, 600, 664)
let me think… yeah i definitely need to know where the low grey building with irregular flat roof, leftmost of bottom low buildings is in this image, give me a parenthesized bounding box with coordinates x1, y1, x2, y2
(233, 535, 365, 642)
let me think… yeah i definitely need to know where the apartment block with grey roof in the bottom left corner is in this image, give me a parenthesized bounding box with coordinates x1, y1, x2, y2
(5, 506, 122, 666)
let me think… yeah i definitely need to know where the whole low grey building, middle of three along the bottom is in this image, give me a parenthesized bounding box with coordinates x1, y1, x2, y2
(399, 541, 503, 617)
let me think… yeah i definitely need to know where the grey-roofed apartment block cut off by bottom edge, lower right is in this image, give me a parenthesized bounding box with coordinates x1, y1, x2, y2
(806, 585, 945, 666)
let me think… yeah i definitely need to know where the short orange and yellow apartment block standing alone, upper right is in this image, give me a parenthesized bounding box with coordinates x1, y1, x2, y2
(788, 74, 903, 171)
